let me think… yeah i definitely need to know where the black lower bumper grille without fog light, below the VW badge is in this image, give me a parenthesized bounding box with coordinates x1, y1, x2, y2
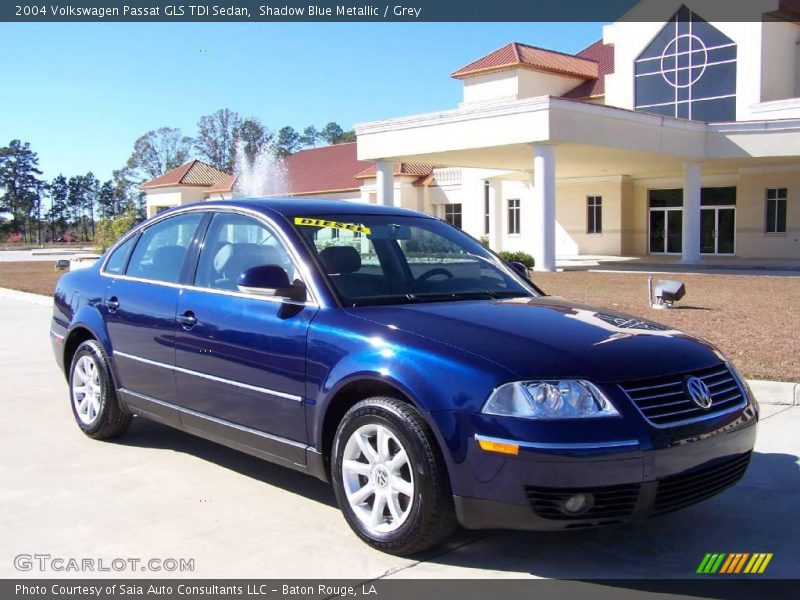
(655, 452, 750, 513)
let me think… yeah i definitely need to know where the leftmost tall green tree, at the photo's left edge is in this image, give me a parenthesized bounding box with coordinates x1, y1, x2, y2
(0, 140, 43, 241)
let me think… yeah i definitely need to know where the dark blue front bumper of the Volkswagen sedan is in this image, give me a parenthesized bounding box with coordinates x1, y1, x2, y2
(438, 401, 758, 530)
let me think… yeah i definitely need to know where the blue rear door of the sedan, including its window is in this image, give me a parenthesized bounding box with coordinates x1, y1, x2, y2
(102, 211, 205, 403)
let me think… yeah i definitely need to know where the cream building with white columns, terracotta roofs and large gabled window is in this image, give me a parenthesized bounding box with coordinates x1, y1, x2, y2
(148, 0, 800, 270)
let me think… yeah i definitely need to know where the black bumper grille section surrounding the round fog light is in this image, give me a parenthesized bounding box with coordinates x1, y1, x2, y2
(525, 483, 639, 520)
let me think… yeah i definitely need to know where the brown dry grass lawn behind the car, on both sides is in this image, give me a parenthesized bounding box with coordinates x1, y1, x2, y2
(0, 261, 800, 381)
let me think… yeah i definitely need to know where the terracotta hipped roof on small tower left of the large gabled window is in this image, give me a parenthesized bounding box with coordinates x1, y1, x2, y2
(451, 42, 598, 79)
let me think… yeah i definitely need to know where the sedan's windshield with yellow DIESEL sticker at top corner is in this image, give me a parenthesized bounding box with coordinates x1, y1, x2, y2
(292, 215, 537, 306)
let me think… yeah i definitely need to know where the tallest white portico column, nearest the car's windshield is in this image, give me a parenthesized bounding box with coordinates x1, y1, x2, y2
(531, 144, 556, 271)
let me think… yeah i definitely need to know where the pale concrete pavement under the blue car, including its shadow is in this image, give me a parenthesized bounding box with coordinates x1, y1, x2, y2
(0, 296, 800, 580)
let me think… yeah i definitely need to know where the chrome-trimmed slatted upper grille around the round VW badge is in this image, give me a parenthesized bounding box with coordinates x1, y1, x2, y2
(621, 364, 746, 427)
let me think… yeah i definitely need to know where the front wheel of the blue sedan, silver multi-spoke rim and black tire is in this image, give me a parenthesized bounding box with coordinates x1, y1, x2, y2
(332, 397, 457, 556)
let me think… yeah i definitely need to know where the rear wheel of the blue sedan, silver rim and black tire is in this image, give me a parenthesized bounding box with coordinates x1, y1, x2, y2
(69, 340, 131, 440)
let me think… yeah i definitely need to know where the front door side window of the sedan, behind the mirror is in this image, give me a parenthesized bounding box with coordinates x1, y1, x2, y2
(194, 212, 299, 291)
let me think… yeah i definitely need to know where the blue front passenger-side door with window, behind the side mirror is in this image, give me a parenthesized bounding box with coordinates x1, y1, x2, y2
(175, 212, 317, 443)
